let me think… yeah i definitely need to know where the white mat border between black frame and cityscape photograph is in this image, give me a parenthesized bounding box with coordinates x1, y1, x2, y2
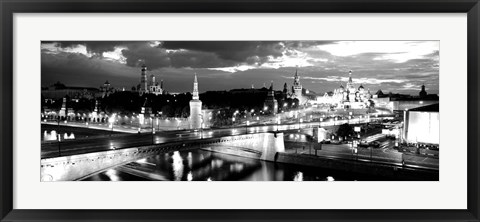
(13, 13, 467, 209)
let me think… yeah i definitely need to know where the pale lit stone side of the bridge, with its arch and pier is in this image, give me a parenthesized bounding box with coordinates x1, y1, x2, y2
(40, 131, 285, 181)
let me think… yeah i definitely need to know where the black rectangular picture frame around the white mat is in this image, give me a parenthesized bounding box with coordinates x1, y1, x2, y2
(0, 0, 480, 221)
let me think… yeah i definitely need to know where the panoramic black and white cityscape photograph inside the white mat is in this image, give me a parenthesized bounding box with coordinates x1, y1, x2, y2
(40, 40, 440, 183)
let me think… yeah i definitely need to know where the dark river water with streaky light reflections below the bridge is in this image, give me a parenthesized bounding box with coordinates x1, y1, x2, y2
(85, 150, 379, 181)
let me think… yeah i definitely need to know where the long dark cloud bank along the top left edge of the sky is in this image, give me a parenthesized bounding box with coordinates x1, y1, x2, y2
(43, 41, 300, 69)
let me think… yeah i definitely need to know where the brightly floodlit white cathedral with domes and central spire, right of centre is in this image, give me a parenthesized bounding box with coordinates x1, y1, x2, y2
(317, 70, 372, 109)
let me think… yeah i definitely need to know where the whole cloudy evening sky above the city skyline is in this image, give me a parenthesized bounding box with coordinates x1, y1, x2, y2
(41, 41, 439, 95)
